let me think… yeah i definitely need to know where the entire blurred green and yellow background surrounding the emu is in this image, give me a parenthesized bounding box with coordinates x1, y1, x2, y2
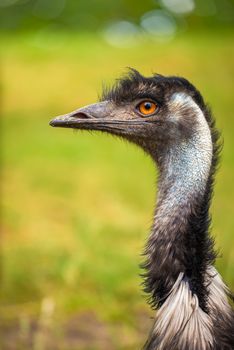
(0, 0, 234, 350)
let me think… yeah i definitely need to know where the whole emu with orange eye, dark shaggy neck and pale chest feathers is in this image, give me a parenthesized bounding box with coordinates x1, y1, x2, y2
(50, 69, 234, 350)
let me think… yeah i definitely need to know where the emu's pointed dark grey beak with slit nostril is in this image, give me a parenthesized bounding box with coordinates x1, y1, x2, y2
(50, 101, 115, 130)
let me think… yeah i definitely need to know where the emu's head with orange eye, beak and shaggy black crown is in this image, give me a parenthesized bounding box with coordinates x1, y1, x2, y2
(50, 69, 211, 162)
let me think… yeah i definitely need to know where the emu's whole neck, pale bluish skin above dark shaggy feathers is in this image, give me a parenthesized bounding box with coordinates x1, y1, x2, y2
(145, 95, 214, 309)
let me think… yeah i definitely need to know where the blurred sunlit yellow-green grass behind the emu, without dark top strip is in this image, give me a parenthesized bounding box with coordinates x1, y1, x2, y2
(0, 32, 234, 349)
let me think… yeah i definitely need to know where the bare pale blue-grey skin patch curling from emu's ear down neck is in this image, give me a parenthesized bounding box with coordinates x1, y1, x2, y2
(155, 93, 213, 202)
